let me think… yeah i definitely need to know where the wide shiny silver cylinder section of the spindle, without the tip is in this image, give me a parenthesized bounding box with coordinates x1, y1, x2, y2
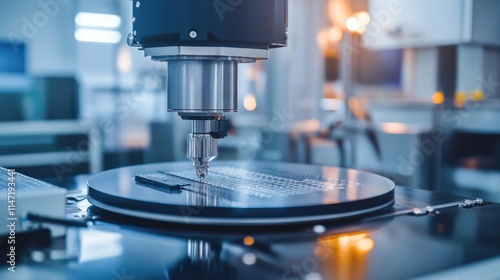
(167, 60, 238, 113)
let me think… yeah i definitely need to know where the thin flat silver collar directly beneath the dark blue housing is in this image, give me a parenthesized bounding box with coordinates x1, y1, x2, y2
(144, 46, 269, 62)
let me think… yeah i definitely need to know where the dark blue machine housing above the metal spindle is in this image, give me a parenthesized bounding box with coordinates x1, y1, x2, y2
(133, 0, 288, 49)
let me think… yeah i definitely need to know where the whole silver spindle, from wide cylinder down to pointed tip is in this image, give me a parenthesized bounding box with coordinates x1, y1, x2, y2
(167, 57, 238, 178)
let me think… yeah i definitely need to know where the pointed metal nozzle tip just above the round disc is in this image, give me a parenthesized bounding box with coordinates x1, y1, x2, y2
(187, 133, 218, 179)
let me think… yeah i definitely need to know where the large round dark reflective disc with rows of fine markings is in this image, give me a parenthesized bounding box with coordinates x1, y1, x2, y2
(87, 161, 394, 225)
